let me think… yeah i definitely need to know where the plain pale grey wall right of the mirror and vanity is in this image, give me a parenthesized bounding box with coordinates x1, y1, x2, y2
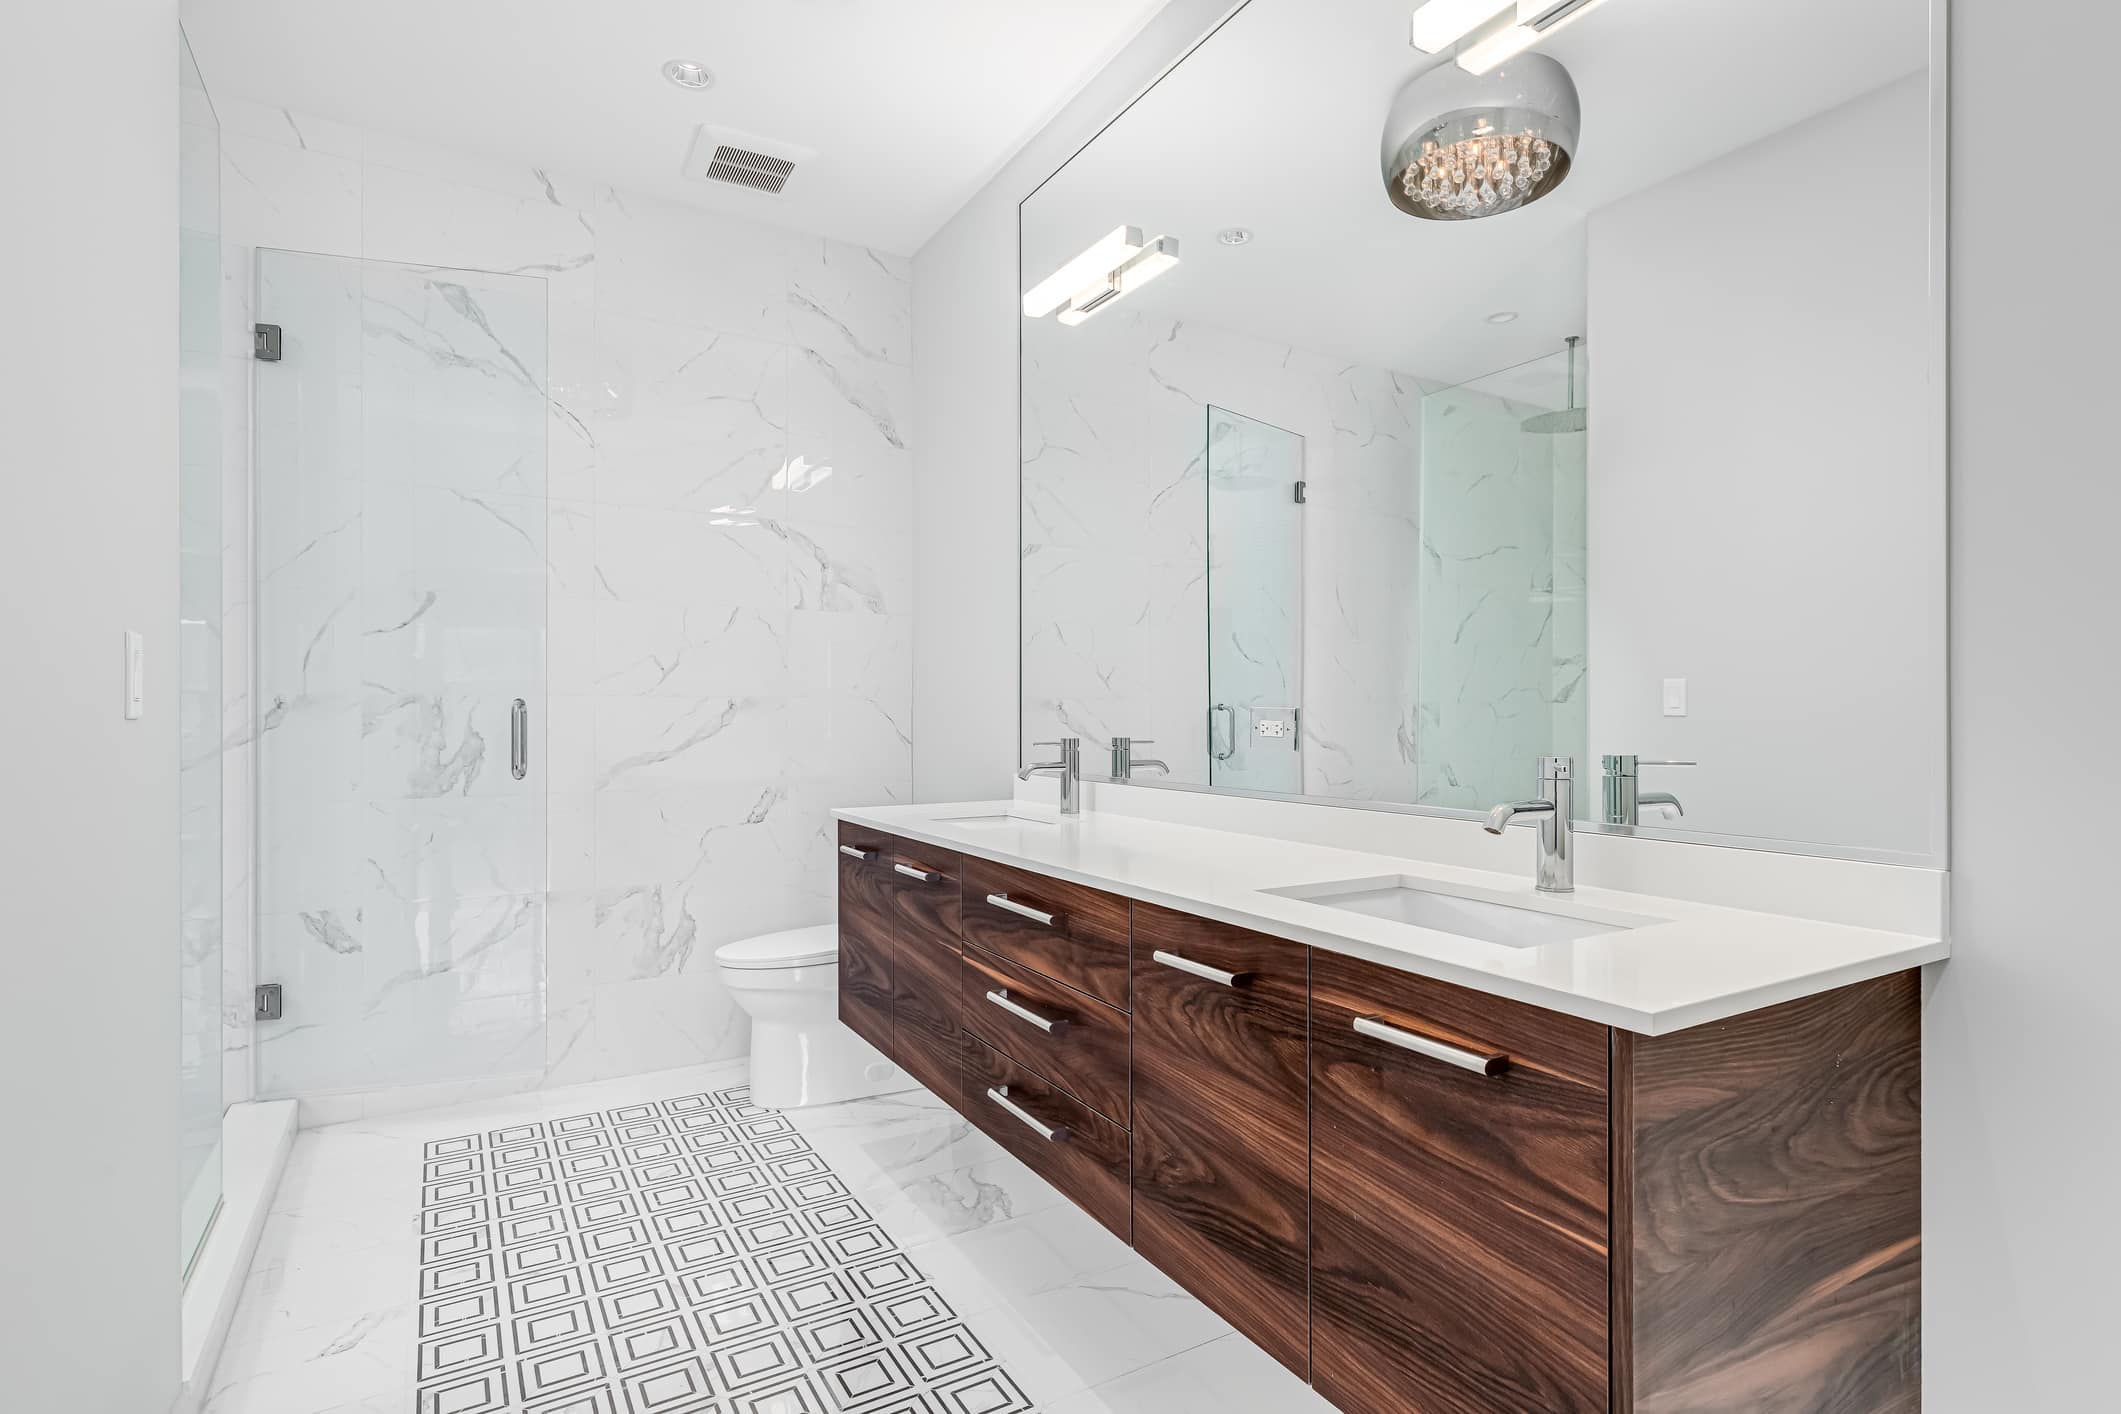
(1922, 0, 2121, 1414)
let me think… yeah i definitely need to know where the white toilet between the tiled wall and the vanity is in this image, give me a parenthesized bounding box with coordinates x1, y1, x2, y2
(715, 922, 914, 1109)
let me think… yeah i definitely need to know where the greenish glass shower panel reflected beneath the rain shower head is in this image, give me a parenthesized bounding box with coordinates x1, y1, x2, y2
(1417, 352, 1597, 816)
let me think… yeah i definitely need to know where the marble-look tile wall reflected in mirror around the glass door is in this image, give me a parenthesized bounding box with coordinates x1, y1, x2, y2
(1022, 310, 1425, 801)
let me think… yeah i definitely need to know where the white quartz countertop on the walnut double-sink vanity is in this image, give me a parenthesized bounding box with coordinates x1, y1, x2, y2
(834, 801, 1951, 1037)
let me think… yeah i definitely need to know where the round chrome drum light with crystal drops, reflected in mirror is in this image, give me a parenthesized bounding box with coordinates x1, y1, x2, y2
(1383, 53, 1582, 220)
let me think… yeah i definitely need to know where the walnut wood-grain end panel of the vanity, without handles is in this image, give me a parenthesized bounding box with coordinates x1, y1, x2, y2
(1623, 971, 1922, 1414)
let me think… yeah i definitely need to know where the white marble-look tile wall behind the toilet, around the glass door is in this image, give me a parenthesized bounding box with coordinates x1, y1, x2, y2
(225, 100, 912, 1090)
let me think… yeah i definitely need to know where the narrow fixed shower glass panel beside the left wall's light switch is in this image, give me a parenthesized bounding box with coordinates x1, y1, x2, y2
(176, 32, 223, 1268)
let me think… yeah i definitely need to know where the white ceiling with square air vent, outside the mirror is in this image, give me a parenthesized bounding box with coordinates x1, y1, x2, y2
(185, 0, 1164, 254)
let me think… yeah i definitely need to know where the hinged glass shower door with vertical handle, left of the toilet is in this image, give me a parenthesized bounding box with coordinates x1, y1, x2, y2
(255, 250, 547, 1096)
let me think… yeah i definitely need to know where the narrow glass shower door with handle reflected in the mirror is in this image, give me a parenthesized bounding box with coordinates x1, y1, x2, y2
(1207, 407, 1304, 793)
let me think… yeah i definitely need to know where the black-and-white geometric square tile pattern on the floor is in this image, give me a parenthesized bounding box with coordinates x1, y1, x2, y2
(416, 1085, 1031, 1414)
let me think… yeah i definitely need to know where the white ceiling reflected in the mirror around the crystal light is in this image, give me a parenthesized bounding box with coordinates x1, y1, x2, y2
(1024, 0, 1930, 382)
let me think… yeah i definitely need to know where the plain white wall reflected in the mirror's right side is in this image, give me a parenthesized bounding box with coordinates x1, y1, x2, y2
(1589, 74, 1945, 859)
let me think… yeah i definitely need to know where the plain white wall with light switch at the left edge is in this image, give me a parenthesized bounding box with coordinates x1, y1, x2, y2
(0, 0, 178, 1414)
